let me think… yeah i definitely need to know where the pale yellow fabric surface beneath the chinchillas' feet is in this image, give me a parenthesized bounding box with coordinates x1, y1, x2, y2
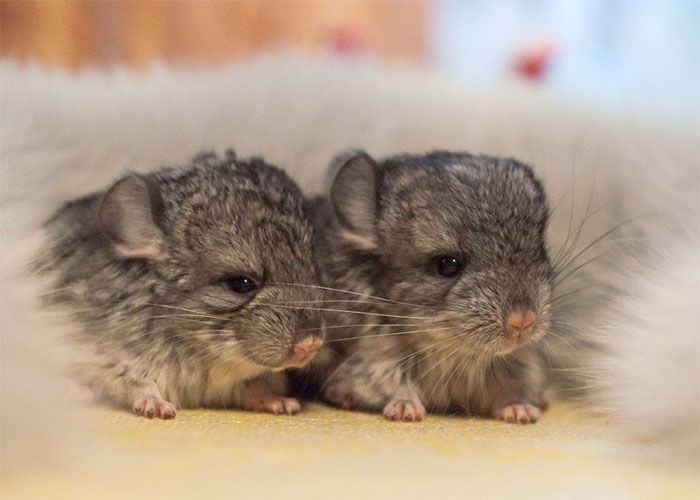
(4, 403, 700, 499)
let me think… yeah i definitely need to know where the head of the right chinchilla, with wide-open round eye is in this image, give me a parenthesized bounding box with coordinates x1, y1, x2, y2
(331, 152, 552, 355)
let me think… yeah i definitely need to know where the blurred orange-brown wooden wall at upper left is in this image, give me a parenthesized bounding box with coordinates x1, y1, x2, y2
(0, 0, 428, 70)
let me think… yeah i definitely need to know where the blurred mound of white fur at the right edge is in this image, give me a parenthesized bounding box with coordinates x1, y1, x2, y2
(593, 220, 700, 461)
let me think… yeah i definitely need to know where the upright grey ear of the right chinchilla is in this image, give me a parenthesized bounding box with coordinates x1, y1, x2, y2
(331, 151, 379, 249)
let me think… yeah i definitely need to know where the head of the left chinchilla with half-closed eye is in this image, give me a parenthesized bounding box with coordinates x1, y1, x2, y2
(97, 154, 322, 368)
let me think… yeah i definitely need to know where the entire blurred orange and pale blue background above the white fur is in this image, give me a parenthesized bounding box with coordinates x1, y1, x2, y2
(0, 0, 700, 110)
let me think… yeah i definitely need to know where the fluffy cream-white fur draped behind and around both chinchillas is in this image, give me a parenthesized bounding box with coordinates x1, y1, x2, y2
(0, 56, 700, 492)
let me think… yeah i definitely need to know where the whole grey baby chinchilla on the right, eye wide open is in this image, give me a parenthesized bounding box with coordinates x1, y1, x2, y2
(315, 152, 553, 423)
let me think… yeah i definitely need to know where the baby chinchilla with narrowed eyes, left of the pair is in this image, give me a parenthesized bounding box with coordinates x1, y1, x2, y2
(38, 152, 323, 418)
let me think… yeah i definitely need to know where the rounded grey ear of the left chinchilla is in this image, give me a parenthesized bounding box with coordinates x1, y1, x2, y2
(97, 174, 163, 259)
